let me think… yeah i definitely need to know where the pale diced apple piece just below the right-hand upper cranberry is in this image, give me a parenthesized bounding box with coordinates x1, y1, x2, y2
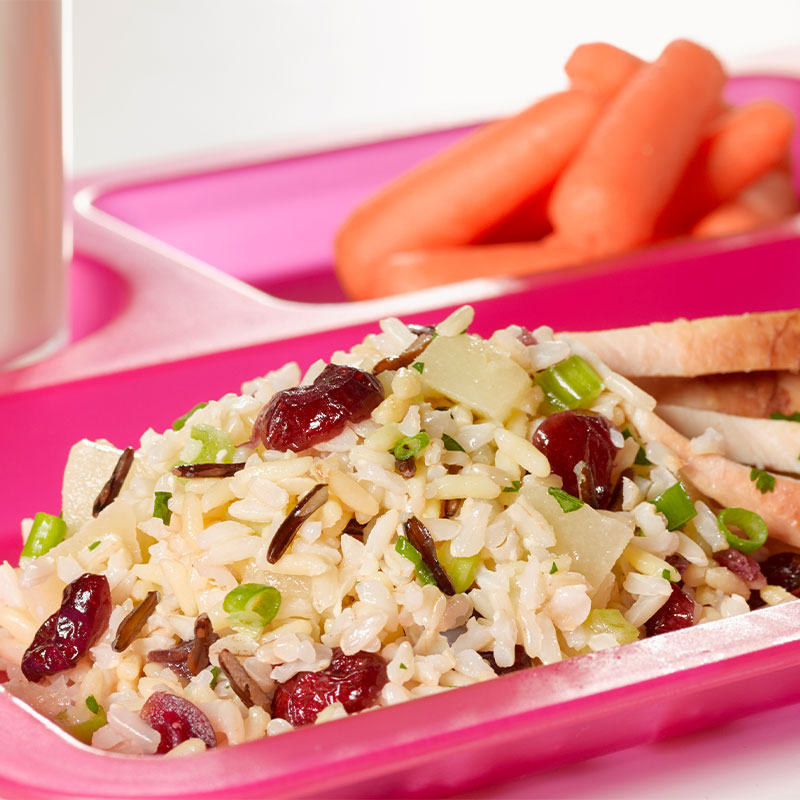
(520, 483, 634, 590)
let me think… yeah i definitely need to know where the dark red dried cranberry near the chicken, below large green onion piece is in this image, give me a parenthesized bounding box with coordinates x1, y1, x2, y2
(533, 411, 617, 508)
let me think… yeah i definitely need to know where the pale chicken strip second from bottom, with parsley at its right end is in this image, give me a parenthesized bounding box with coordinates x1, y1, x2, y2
(657, 403, 800, 474)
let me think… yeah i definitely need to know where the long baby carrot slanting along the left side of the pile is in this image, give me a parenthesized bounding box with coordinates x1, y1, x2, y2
(335, 90, 601, 299)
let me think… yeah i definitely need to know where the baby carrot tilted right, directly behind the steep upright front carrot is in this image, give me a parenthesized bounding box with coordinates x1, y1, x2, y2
(657, 100, 794, 235)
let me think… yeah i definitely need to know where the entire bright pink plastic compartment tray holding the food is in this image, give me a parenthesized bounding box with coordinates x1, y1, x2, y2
(0, 72, 800, 798)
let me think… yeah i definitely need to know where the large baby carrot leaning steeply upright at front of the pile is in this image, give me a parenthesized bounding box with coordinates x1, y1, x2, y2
(549, 40, 725, 256)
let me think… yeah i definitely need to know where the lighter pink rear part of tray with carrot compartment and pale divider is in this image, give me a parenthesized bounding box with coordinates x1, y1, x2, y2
(0, 76, 800, 400)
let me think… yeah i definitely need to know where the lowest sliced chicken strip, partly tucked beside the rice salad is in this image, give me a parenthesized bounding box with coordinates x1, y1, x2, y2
(627, 406, 800, 547)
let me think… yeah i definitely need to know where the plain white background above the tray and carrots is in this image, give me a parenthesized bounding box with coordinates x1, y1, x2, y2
(72, 0, 800, 173)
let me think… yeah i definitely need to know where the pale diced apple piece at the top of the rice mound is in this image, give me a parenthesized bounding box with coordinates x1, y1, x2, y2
(421, 334, 531, 422)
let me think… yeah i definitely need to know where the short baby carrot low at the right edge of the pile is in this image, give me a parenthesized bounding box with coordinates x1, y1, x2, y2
(691, 170, 797, 239)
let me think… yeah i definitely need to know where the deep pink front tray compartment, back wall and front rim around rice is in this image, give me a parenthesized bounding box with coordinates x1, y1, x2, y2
(0, 245, 800, 798)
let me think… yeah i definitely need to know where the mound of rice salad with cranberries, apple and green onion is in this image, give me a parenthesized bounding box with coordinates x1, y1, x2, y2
(0, 307, 794, 755)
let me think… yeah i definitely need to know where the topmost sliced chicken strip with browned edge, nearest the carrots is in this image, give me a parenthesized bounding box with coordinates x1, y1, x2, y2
(565, 310, 800, 377)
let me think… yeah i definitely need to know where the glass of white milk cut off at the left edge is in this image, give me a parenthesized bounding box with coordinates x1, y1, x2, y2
(0, 0, 72, 369)
